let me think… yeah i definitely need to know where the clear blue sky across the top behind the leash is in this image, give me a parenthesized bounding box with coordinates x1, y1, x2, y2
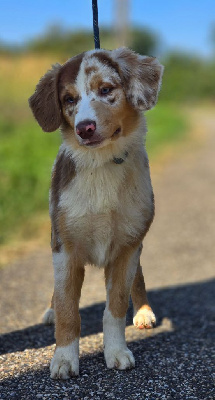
(0, 0, 215, 56)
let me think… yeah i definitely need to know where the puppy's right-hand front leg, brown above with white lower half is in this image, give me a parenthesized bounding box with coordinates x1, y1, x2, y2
(103, 249, 139, 369)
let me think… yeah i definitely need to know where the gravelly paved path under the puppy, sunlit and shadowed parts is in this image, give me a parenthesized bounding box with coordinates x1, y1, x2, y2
(0, 111, 215, 400)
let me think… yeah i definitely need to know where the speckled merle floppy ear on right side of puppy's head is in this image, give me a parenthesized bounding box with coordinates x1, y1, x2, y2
(112, 48, 164, 110)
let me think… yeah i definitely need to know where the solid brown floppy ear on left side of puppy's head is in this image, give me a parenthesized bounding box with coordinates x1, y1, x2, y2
(29, 64, 62, 132)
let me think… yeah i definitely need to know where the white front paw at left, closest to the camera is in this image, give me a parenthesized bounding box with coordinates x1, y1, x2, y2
(50, 339, 79, 379)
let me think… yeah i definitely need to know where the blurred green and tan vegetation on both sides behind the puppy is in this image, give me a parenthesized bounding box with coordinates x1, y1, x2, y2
(0, 27, 215, 245)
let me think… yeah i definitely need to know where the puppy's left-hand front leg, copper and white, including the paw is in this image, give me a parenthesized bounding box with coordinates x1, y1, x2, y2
(50, 249, 84, 379)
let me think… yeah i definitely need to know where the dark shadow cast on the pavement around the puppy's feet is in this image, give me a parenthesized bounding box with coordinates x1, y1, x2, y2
(1, 280, 215, 400)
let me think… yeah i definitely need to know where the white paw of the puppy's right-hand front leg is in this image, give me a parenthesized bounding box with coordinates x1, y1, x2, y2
(105, 347, 135, 370)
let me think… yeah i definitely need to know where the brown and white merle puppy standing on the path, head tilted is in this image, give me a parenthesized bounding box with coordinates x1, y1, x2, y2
(29, 48, 163, 379)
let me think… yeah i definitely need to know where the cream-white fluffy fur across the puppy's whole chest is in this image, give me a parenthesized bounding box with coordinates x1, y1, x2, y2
(59, 150, 151, 266)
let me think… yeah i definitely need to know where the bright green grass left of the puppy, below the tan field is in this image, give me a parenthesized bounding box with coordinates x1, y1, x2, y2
(0, 118, 60, 244)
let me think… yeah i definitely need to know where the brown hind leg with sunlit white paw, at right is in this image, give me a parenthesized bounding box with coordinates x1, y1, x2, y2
(131, 252, 156, 329)
